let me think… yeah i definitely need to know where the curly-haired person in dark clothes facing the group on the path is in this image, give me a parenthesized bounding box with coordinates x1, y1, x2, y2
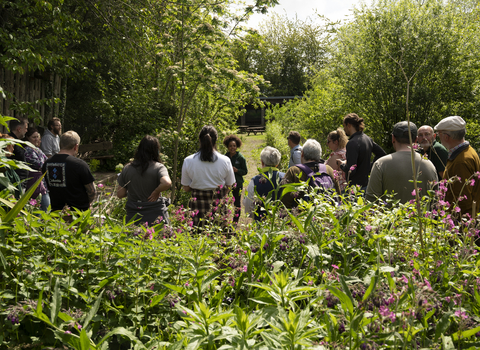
(223, 135, 248, 223)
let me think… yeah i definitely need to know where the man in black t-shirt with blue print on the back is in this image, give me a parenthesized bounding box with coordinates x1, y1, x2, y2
(42, 131, 96, 211)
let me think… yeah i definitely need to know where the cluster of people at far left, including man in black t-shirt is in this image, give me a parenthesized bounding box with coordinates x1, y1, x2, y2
(2, 118, 96, 211)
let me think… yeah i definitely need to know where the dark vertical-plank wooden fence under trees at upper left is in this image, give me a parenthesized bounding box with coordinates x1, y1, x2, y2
(0, 67, 62, 131)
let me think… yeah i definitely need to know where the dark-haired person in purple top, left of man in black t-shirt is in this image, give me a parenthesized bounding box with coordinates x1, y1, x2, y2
(25, 128, 50, 212)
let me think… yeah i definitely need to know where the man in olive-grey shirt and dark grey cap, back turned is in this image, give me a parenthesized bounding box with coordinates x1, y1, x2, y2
(366, 121, 437, 203)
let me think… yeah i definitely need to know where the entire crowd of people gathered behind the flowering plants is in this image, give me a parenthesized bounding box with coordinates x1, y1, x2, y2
(2, 113, 480, 226)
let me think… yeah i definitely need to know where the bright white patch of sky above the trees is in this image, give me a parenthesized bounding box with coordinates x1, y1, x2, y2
(247, 0, 371, 28)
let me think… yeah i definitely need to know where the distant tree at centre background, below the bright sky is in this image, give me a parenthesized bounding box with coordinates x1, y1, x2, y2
(234, 13, 330, 96)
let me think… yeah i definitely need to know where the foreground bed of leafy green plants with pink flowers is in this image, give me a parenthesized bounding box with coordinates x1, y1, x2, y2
(0, 185, 480, 349)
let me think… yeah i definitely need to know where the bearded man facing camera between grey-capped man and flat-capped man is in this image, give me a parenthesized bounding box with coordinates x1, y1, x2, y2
(417, 125, 448, 180)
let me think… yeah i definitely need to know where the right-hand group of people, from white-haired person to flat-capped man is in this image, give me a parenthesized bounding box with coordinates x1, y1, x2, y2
(243, 113, 480, 220)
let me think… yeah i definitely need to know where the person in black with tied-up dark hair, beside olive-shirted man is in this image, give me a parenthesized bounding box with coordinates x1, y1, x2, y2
(337, 113, 386, 190)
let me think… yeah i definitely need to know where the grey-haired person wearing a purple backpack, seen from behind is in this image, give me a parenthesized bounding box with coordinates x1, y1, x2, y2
(282, 139, 340, 208)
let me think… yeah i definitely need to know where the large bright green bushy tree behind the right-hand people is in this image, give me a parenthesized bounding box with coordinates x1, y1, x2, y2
(269, 0, 480, 149)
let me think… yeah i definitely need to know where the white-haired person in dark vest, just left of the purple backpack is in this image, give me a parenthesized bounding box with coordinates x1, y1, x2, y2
(243, 146, 285, 221)
